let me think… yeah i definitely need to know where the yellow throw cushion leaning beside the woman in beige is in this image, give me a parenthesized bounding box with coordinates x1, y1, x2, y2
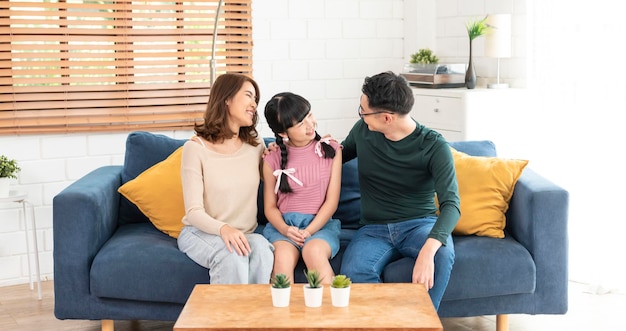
(117, 147, 185, 238)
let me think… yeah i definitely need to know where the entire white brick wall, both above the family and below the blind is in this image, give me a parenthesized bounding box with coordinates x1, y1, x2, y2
(0, 0, 528, 286)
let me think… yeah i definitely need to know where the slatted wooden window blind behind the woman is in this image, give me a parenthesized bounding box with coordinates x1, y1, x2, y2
(0, 0, 252, 134)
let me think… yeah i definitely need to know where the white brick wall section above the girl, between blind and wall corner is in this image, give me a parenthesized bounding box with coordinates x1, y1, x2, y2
(252, 0, 405, 138)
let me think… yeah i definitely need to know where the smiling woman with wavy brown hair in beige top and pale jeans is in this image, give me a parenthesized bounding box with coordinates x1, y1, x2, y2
(178, 74, 274, 284)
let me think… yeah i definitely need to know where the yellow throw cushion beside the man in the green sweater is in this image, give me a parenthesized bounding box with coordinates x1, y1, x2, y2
(452, 149, 528, 238)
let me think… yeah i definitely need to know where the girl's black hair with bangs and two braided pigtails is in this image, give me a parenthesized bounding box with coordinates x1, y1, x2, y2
(265, 92, 335, 193)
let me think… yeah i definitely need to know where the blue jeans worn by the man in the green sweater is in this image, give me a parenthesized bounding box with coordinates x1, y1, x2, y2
(341, 217, 454, 310)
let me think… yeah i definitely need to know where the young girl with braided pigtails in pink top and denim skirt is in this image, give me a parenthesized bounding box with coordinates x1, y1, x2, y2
(263, 92, 341, 284)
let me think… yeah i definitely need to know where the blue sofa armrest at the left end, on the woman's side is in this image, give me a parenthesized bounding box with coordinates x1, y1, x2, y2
(52, 166, 122, 319)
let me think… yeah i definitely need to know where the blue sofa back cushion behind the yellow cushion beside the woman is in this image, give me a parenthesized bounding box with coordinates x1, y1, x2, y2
(119, 131, 186, 224)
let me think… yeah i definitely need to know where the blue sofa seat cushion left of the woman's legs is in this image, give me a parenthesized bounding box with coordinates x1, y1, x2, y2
(89, 223, 209, 304)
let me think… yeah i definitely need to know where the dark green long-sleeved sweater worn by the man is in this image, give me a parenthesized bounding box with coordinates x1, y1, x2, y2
(342, 120, 460, 244)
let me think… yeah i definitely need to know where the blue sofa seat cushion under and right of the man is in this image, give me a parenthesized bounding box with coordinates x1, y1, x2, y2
(383, 236, 537, 301)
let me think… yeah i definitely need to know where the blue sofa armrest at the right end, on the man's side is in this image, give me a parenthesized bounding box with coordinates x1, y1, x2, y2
(506, 168, 569, 314)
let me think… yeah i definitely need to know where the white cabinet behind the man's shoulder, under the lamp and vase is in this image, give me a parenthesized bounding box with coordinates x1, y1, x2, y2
(411, 88, 528, 145)
